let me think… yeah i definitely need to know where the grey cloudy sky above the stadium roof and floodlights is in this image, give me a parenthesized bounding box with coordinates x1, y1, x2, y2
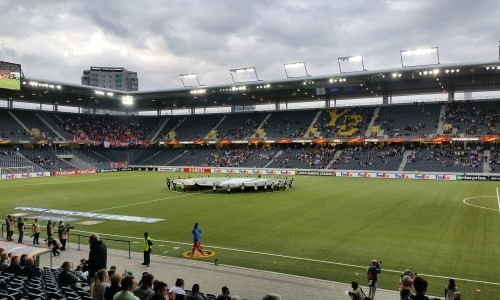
(0, 0, 500, 90)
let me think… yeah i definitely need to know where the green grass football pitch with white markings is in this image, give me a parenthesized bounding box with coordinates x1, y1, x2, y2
(0, 172, 500, 299)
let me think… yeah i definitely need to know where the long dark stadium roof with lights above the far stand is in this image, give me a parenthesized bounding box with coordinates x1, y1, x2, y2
(0, 60, 500, 111)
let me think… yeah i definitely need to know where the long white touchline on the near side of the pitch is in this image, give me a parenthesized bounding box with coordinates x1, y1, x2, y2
(73, 230, 500, 286)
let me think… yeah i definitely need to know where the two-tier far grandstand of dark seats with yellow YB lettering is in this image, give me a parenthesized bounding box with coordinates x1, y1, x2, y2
(0, 100, 500, 172)
